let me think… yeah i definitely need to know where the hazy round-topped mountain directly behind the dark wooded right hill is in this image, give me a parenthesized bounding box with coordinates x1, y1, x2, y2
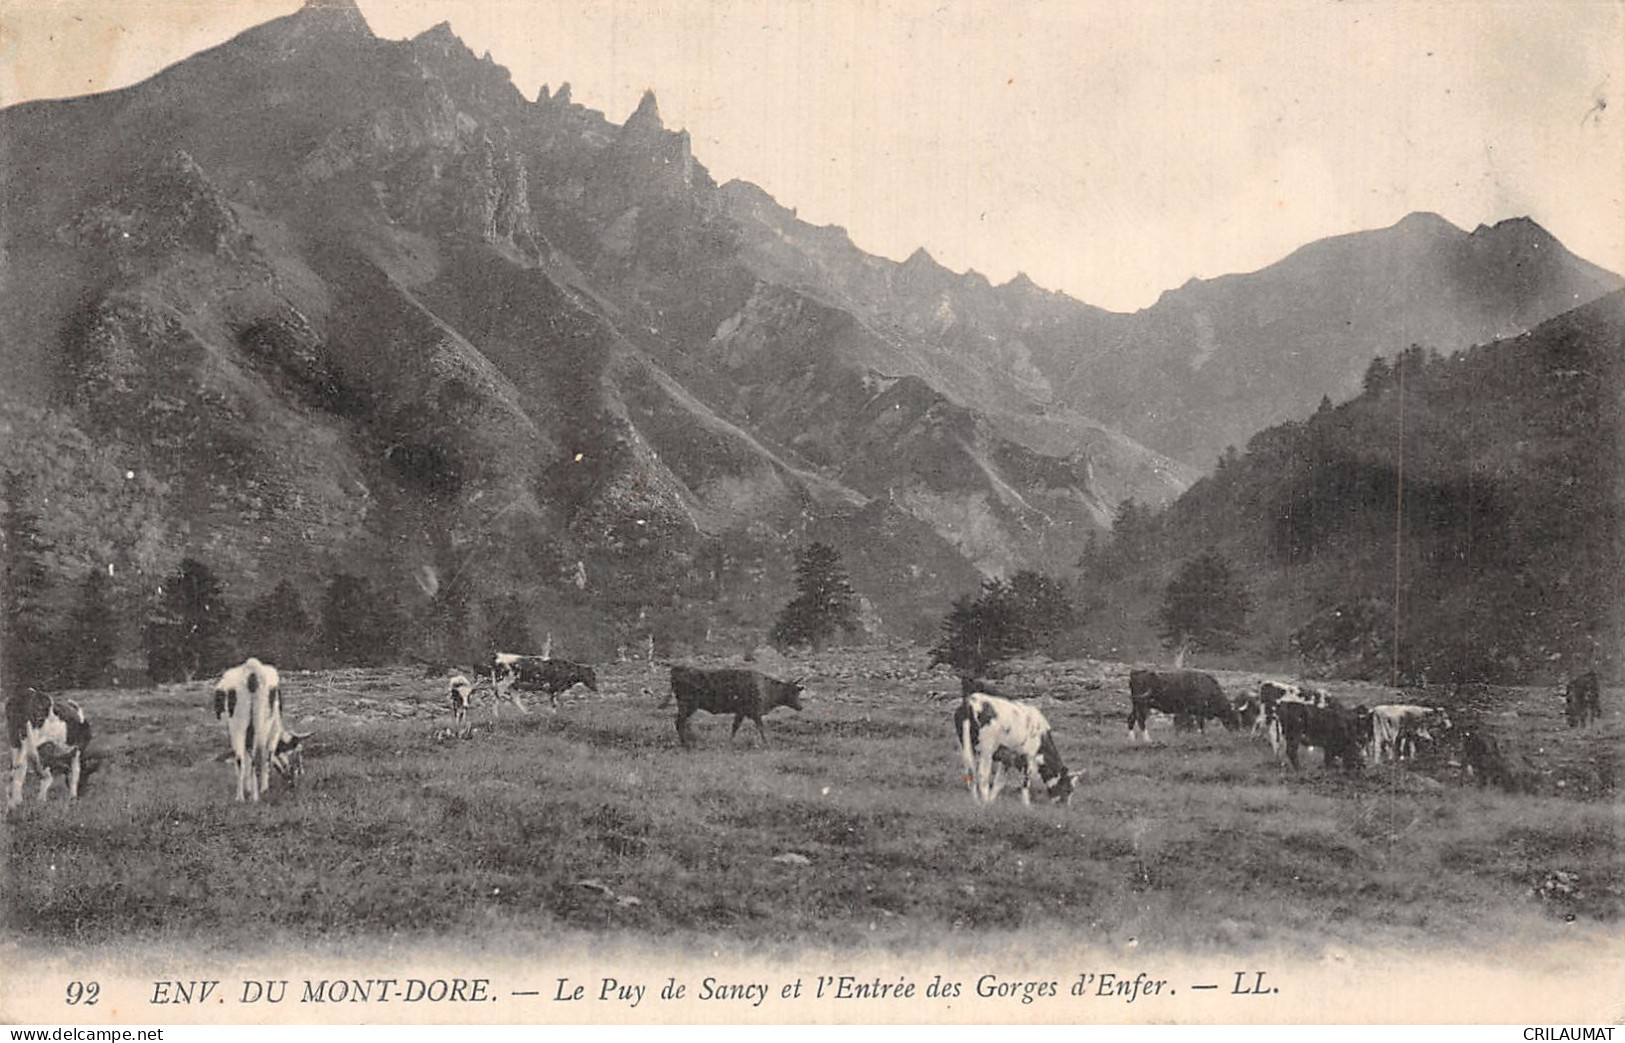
(1035, 214, 1622, 466)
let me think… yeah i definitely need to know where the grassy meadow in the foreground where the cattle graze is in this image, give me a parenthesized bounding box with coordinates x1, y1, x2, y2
(3, 648, 1625, 952)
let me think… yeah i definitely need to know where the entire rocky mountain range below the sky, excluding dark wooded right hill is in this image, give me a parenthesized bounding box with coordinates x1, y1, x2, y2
(0, 0, 1620, 643)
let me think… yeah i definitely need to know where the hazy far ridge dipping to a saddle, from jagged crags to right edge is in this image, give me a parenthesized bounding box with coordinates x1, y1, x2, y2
(722, 182, 1625, 474)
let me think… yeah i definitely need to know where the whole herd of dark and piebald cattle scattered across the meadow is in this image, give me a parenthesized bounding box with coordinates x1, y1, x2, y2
(7, 653, 1602, 809)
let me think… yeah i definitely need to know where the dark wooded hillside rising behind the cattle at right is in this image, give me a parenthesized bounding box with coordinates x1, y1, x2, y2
(1087, 291, 1625, 682)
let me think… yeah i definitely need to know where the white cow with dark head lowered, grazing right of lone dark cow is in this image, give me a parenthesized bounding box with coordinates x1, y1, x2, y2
(954, 692, 1077, 804)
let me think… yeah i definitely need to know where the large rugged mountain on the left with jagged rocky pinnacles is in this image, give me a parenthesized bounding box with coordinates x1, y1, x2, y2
(0, 0, 1118, 655)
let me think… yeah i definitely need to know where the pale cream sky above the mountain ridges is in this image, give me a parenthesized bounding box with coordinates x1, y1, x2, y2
(0, 0, 1625, 310)
